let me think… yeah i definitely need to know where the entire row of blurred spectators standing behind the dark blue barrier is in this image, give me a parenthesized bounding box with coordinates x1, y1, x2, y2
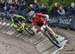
(0, 0, 75, 16)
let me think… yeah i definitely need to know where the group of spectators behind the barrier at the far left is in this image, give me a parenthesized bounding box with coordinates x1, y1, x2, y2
(0, 1, 26, 13)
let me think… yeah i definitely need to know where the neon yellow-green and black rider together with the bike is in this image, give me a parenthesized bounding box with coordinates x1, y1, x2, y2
(11, 15, 34, 35)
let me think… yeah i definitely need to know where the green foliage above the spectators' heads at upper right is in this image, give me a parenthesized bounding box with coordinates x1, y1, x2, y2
(38, 0, 75, 12)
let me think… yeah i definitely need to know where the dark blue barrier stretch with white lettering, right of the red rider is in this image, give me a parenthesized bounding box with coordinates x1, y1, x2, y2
(49, 15, 75, 29)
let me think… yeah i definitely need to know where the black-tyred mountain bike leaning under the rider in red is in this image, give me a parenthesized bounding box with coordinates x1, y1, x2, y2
(38, 17, 65, 48)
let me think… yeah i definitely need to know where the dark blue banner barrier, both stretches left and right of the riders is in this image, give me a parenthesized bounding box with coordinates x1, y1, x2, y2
(0, 11, 75, 30)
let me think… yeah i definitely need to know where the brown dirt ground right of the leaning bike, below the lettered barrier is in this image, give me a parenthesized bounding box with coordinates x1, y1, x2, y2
(53, 28, 75, 54)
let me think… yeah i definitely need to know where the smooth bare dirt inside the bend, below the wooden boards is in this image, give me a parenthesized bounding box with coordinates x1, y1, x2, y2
(0, 33, 39, 54)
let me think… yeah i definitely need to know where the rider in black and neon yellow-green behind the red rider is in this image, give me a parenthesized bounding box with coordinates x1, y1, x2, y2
(12, 15, 25, 32)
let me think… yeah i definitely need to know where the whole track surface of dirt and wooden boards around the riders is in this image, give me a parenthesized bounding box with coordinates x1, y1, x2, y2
(0, 21, 75, 54)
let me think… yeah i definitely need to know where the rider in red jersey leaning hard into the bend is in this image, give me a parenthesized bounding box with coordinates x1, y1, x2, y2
(31, 13, 64, 40)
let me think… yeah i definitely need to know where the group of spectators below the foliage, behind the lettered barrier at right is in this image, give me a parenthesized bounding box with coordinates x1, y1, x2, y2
(50, 2, 75, 16)
